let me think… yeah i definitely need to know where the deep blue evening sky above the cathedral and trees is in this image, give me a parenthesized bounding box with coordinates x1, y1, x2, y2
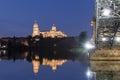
(0, 0, 94, 37)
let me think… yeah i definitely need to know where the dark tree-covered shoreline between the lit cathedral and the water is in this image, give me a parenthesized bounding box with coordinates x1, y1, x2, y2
(0, 32, 88, 52)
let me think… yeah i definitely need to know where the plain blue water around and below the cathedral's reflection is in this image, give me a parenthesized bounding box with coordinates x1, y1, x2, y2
(0, 60, 91, 80)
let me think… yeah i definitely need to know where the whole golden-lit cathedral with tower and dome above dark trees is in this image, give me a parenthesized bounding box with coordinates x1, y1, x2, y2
(32, 22, 67, 38)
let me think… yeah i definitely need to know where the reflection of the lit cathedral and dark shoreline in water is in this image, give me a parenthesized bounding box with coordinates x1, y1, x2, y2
(0, 50, 87, 74)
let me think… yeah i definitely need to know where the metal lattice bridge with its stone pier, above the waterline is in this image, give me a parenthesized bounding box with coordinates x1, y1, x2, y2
(90, 0, 120, 60)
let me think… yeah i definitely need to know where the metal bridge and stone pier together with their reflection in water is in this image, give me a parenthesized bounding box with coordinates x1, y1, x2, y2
(90, 0, 120, 80)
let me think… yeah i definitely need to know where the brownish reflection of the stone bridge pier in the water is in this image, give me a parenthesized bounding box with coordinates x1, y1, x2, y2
(90, 61, 120, 80)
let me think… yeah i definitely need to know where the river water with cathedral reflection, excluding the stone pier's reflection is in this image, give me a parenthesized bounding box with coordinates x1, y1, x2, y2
(0, 51, 93, 80)
